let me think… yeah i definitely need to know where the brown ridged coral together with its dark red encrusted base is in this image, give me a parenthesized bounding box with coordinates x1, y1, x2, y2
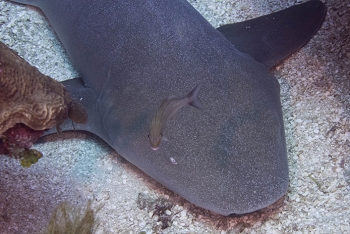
(0, 42, 88, 165)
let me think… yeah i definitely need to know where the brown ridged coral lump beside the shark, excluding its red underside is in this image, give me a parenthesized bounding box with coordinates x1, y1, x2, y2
(0, 42, 87, 135)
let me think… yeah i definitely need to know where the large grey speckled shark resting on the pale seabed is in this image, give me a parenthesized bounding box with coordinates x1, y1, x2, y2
(8, 0, 326, 215)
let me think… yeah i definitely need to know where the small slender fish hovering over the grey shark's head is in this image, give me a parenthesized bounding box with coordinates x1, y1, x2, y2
(148, 83, 203, 150)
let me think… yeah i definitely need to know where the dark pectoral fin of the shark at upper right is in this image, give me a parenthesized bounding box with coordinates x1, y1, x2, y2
(217, 0, 327, 68)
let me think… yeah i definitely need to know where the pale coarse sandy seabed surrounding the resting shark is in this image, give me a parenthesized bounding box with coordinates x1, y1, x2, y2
(0, 0, 350, 234)
